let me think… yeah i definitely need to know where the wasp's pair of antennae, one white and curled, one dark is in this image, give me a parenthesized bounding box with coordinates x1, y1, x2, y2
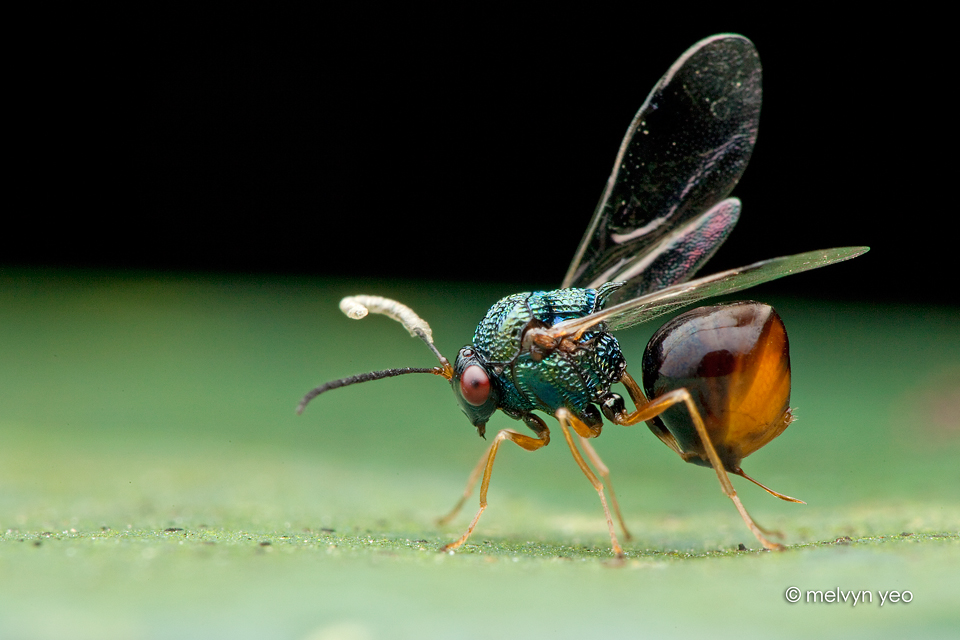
(297, 295, 453, 415)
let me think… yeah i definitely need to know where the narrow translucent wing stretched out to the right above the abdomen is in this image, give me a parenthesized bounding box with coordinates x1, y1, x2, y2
(544, 247, 869, 340)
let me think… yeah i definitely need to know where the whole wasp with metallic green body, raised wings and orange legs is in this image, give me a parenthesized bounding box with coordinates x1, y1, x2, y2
(297, 34, 868, 557)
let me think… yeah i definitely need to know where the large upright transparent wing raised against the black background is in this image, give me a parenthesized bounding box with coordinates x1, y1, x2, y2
(562, 34, 762, 295)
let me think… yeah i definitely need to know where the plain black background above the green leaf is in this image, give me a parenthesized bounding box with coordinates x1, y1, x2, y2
(11, 5, 960, 303)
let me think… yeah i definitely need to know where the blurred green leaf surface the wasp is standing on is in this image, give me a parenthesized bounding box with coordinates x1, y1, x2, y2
(0, 271, 960, 640)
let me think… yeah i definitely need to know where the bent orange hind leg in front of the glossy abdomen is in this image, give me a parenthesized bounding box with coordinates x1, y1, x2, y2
(616, 373, 783, 550)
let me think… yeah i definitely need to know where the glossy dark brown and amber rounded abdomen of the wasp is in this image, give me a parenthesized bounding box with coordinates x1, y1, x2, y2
(643, 302, 793, 471)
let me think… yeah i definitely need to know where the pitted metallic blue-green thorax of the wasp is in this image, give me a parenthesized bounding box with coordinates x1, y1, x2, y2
(473, 282, 626, 422)
